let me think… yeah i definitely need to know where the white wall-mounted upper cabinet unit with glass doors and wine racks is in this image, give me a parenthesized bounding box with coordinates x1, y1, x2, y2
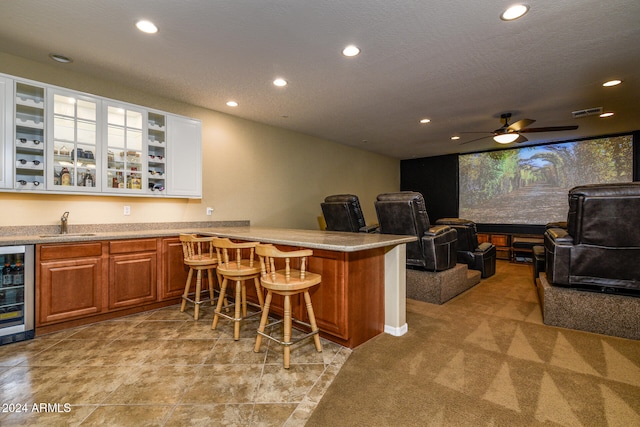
(0, 74, 202, 198)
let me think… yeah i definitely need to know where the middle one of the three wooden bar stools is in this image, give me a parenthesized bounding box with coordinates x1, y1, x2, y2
(211, 238, 264, 341)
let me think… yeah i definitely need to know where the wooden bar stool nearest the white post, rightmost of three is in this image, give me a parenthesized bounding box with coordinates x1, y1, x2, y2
(253, 245, 322, 369)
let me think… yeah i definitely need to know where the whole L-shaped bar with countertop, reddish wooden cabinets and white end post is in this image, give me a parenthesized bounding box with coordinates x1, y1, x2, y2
(0, 223, 415, 348)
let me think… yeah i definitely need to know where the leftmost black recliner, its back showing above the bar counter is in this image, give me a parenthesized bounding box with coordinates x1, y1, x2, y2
(320, 194, 378, 233)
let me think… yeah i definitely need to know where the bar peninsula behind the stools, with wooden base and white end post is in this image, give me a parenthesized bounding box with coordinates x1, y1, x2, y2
(198, 226, 416, 348)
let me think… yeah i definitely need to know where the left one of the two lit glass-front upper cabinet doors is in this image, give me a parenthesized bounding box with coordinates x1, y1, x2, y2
(47, 91, 100, 192)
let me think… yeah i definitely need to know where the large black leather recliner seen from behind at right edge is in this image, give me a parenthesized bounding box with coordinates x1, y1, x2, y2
(544, 183, 640, 296)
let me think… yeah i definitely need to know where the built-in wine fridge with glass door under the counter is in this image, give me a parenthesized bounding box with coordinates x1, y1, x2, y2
(0, 245, 35, 345)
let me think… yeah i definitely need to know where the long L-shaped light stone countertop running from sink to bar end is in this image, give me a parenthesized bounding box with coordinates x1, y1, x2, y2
(0, 221, 416, 252)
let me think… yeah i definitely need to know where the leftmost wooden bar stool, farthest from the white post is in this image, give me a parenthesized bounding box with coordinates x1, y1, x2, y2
(180, 234, 218, 320)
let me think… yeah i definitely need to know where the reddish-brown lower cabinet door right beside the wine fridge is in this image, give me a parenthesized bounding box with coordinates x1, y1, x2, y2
(36, 257, 103, 325)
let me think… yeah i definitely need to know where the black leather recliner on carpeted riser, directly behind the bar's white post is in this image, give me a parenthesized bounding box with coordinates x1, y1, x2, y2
(375, 191, 458, 271)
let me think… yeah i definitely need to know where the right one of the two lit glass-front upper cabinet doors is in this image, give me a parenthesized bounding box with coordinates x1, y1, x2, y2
(104, 103, 147, 193)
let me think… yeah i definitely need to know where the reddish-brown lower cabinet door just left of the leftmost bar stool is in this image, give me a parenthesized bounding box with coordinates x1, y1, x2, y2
(160, 237, 190, 300)
